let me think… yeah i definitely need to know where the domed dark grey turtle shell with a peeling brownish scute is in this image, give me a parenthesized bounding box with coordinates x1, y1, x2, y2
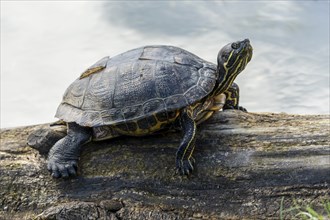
(56, 46, 218, 127)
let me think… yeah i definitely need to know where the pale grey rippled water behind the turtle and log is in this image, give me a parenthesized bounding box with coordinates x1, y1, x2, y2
(1, 1, 329, 127)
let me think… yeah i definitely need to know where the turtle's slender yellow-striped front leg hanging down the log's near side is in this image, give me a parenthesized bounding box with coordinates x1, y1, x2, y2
(176, 109, 196, 175)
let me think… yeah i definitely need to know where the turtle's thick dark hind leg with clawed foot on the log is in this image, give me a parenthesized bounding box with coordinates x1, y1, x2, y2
(47, 123, 92, 178)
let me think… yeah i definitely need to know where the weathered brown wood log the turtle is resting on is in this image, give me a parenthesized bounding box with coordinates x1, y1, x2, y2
(0, 111, 330, 219)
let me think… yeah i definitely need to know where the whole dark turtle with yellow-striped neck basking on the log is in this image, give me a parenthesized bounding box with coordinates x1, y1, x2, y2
(30, 39, 253, 178)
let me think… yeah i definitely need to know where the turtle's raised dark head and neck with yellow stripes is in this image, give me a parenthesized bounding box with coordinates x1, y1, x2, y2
(214, 39, 252, 94)
